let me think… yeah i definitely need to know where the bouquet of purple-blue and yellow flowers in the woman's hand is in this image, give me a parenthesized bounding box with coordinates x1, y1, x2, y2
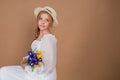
(27, 50, 42, 72)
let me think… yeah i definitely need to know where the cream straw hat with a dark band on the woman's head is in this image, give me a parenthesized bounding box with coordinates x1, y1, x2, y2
(34, 6, 58, 27)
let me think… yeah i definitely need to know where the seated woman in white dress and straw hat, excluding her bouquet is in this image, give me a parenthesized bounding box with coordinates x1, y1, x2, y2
(0, 6, 58, 80)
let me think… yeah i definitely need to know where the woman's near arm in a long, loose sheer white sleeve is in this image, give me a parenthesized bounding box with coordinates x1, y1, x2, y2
(35, 37, 56, 73)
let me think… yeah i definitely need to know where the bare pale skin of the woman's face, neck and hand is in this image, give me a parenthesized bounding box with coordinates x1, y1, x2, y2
(20, 13, 53, 69)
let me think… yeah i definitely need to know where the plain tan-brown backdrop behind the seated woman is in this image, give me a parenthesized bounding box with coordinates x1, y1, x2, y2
(0, 0, 120, 80)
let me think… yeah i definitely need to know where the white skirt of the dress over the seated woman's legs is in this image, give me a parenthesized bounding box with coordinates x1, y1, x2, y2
(0, 66, 56, 80)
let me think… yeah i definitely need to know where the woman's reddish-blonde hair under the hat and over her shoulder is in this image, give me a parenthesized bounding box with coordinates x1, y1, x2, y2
(35, 11, 53, 39)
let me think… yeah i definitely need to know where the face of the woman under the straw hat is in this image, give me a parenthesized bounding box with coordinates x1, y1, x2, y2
(38, 13, 52, 31)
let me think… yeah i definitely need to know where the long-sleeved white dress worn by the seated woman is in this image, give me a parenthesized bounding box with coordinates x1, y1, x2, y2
(0, 34, 57, 80)
